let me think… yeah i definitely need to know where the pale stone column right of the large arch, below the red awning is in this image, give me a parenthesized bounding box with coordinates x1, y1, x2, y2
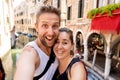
(104, 34, 112, 80)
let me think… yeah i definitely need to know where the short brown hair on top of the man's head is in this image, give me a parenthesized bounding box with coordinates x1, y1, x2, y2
(36, 5, 61, 22)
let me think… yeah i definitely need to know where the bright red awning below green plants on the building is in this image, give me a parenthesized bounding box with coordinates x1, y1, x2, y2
(91, 9, 120, 33)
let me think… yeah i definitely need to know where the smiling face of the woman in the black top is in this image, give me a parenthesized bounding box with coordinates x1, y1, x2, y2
(53, 32, 73, 59)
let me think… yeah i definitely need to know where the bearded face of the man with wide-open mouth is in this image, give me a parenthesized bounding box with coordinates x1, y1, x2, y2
(36, 13, 60, 47)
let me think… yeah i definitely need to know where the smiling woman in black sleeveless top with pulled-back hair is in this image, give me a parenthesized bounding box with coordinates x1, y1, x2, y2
(53, 28, 87, 80)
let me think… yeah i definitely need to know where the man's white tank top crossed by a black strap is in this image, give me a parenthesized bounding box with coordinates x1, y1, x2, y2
(26, 41, 58, 80)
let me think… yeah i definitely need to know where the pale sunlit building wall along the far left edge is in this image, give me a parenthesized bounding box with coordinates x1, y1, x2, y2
(0, 0, 14, 80)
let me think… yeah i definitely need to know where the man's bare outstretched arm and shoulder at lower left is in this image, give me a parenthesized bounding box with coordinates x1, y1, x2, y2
(14, 47, 38, 80)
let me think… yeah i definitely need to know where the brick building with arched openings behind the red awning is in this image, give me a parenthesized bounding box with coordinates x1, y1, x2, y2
(60, 0, 120, 80)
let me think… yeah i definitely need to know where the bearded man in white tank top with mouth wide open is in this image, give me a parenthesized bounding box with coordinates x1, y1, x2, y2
(14, 6, 60, 80)
